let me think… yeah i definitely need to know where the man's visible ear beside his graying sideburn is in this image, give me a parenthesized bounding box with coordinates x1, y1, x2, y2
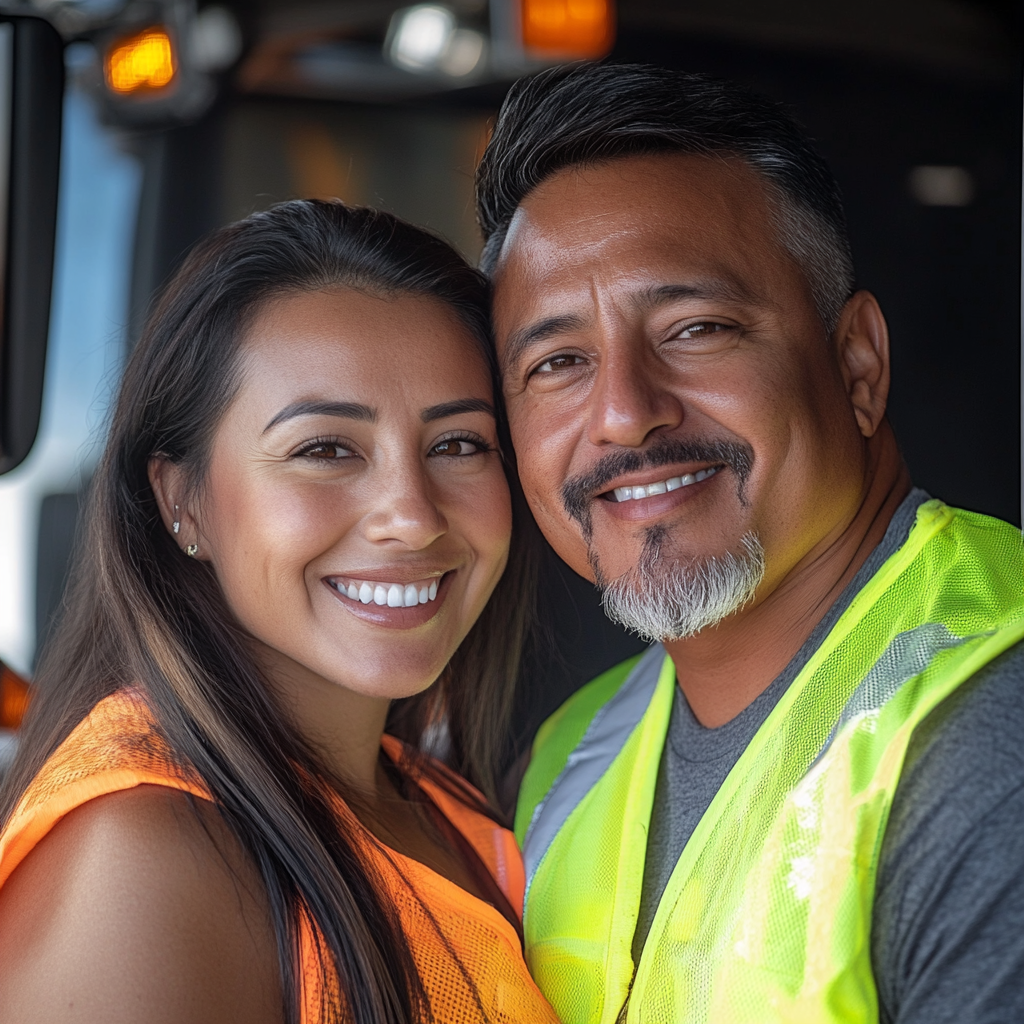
(833, 292, 889, 437)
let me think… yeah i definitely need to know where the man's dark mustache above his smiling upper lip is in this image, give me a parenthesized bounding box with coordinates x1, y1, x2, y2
(562, 437, 754, 536)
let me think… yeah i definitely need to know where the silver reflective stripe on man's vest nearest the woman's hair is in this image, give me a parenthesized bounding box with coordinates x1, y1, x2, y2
(522, 644, 668, 894)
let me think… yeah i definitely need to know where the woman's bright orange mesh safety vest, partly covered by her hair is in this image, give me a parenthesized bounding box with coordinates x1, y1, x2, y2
(0, 690, 558, 1024)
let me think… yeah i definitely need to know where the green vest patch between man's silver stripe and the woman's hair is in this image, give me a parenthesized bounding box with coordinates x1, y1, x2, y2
(515, 654, 643, 846)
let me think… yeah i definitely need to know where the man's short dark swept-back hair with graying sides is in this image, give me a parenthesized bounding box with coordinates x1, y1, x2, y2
(476, 63, 854, 335)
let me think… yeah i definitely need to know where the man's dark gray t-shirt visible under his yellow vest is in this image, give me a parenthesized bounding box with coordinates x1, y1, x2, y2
(633, 489, 1024, 1024)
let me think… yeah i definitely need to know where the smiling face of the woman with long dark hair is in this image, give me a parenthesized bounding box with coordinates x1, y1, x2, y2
(184, 288, 512, 697)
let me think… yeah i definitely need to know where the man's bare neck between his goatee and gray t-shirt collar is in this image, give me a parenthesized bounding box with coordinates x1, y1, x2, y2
(665, 424, 910, 728)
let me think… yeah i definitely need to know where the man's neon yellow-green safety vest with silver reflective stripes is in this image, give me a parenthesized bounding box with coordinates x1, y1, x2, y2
(516, 501, 1024, 1024)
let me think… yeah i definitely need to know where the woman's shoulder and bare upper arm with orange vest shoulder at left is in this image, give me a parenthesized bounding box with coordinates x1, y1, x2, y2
(0, 689, 281, 1024)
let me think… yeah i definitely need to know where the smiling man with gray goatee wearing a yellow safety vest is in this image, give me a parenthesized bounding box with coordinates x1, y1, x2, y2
(478, 66, 1024, 1024)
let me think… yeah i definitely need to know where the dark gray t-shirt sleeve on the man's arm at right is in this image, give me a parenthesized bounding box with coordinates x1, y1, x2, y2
(871, 644, 1024, 1024)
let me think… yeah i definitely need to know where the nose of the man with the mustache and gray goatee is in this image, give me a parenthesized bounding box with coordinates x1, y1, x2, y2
(589, 337, 683, 447)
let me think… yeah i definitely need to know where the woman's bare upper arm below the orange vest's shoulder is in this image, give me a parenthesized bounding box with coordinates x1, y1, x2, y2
(0, 785, 283, 1024)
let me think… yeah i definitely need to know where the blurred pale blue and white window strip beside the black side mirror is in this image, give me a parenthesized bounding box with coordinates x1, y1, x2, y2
(0, 61, 141, 673)
